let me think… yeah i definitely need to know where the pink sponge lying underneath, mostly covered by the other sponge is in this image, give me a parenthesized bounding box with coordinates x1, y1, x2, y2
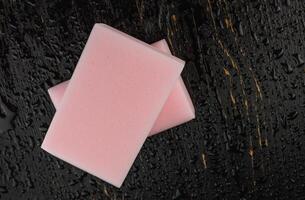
(48, 40, 195, 136)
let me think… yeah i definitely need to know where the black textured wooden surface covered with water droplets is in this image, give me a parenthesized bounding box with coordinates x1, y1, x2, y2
(0, 0, 305, 200)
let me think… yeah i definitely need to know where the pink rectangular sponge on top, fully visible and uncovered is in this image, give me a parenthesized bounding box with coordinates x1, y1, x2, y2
(41, 24, 184, 187)
